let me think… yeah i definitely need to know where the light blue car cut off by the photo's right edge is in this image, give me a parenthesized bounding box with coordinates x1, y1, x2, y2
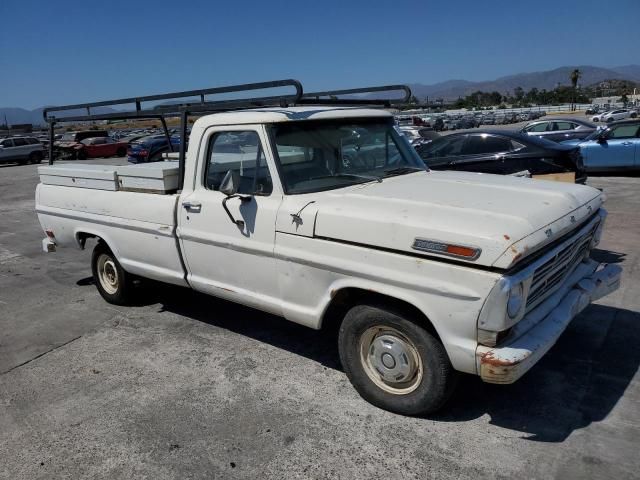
(562, 119, 640, 172)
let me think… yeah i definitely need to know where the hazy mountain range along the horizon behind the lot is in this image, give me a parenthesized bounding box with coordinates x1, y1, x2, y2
(0, 65, 640, 125)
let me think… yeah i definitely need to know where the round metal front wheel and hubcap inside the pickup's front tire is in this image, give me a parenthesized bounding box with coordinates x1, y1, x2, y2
(360, 326, 423, 395)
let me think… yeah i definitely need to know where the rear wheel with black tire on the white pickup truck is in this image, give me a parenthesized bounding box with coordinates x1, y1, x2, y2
(91, 242, 133, 305)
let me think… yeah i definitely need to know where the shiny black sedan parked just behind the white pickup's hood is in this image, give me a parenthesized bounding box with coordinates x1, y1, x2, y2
(417, 130, 586, 183)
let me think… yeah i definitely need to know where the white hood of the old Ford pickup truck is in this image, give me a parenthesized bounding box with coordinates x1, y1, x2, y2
(308, 171, 603, 268)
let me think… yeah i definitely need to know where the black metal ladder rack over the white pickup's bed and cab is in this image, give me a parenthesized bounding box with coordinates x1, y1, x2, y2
(42, 79, 411, 189)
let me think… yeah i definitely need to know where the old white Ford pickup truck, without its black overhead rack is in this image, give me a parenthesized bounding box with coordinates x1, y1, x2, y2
(36, 106, 621, 414)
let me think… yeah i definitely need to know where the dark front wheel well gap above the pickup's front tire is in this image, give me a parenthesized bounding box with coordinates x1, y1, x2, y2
(322, 288, 440, 340)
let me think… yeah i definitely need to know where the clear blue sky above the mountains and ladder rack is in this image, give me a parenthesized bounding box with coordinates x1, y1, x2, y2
(0, 0, 640, 109)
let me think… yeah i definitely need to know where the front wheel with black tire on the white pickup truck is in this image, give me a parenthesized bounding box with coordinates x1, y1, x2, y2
(338, 305, 457, 415)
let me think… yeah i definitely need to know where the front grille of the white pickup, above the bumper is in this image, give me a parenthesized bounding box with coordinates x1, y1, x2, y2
(526, 222, 599, 311)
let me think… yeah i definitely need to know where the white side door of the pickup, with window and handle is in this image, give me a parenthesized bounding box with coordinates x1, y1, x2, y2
(178, 125, 282, 314)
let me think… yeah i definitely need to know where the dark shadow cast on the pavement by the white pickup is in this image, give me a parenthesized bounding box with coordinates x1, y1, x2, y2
(78, 279, 640, 442)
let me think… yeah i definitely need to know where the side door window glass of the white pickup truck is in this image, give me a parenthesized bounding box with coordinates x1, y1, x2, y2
(205, 131, 273, 195)
